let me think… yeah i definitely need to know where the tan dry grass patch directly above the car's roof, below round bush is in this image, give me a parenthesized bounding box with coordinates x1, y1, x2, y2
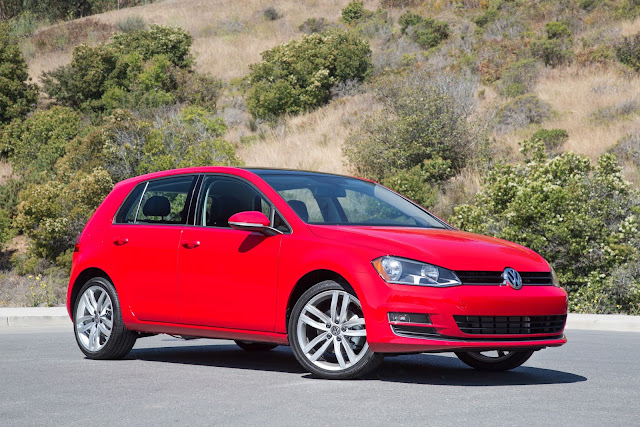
(238, 94, 378, 173)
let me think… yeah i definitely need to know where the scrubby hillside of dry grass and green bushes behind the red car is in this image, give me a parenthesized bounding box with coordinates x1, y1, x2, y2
(0, 0, 640, 312)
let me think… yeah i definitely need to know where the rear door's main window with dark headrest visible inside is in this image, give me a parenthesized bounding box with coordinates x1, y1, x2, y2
(135, 175, 196, 224)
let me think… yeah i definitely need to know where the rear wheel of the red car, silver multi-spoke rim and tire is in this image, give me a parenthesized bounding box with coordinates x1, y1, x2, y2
(73, 277, 138, 359)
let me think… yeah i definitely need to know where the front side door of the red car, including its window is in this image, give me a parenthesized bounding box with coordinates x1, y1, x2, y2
(178, 175, 284, 331)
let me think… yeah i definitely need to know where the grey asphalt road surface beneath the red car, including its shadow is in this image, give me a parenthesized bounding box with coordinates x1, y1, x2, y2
(0, 328, 640, 426)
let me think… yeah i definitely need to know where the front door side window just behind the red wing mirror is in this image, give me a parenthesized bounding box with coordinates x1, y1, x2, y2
(196, 176, 271, 227)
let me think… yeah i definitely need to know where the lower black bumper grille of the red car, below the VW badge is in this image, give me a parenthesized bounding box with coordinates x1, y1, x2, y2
(453, 314, 567, 335)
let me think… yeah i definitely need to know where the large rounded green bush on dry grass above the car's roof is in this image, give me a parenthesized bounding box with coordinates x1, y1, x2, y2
(247, 31, 372, 119)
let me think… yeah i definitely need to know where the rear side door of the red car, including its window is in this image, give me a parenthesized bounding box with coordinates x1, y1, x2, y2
(109, 175, 197, 323)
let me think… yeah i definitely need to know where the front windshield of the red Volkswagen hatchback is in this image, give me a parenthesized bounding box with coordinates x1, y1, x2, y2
(256, 171, 447, 228)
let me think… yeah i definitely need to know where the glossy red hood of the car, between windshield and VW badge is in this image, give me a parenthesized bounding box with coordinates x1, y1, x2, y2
(309, 225, 549, 271)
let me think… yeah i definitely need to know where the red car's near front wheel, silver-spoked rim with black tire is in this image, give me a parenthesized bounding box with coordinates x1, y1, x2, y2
(288, 280, 383, 379)
